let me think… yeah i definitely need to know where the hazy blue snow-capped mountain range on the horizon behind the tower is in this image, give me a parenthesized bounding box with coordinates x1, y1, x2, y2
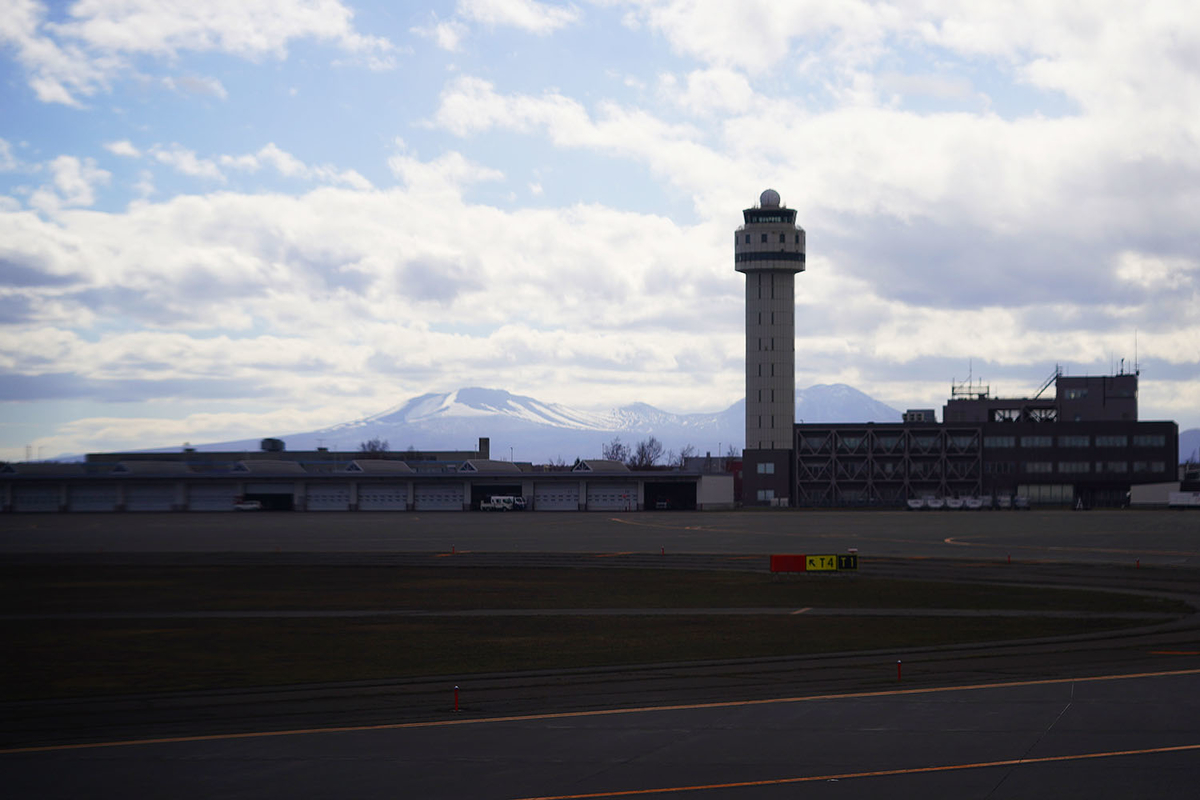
(199, 384, 900, 463)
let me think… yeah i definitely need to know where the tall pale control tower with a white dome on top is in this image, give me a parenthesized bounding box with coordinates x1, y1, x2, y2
(733, 190, 804, 505)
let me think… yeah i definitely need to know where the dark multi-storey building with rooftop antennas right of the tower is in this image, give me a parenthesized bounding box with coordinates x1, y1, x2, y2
(787, 374, 1178, 507)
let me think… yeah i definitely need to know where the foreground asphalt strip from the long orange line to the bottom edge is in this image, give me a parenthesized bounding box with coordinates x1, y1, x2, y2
(9, 668, 1200, 800)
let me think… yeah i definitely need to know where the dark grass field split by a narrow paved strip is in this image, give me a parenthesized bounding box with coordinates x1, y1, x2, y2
(0, 566, 1189, 699)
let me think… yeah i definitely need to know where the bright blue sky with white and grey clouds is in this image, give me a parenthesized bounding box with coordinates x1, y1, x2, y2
(0, 0, 1200, 459)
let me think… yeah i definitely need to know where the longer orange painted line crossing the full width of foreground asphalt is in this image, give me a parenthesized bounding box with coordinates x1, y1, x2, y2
(0, 668, 1200, 756)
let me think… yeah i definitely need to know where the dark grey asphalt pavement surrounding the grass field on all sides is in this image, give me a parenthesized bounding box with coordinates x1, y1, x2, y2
(0, 512, 1200, 800)
